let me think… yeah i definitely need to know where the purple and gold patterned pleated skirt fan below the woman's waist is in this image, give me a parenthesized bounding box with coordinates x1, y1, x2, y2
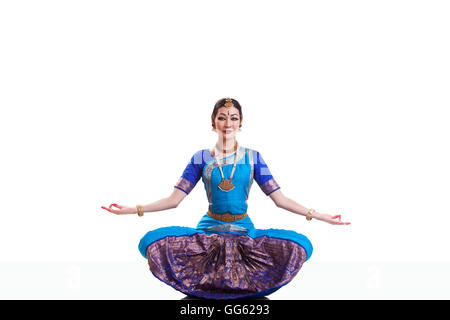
(144, 232, 307, 299)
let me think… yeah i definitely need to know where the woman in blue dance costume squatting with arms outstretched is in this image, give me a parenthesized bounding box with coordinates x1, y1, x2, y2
(102, 98, 349, 299)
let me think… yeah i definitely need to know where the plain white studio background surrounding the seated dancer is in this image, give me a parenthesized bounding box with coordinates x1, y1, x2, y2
(0, 0, 450, 299)
